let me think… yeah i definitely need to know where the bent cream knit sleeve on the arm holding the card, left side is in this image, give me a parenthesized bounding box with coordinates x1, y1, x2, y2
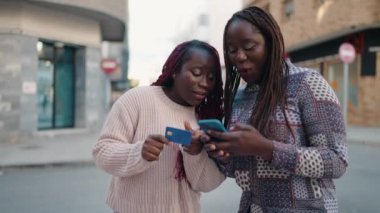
(93, 91, 152, 177)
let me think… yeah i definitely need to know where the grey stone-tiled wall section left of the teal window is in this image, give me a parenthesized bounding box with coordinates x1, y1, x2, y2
(0, 34, 37, 143)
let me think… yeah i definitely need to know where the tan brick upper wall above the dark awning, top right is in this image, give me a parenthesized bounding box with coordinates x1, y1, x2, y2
(243, 0, 380, 49)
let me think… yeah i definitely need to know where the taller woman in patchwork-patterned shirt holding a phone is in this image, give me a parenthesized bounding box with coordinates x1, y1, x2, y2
(205, 7, 347, 213)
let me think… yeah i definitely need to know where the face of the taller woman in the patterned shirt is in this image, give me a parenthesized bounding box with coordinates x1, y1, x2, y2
(226, 19, 267, 84)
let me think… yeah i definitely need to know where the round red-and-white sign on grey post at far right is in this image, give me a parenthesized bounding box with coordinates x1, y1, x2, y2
(339, 42, 355, 126)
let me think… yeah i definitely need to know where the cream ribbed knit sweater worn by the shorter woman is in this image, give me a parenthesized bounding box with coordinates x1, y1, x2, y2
(93, 86, 225, 213)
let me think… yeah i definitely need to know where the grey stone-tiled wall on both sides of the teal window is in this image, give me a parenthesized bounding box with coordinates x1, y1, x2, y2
(0, 34, 109, 144)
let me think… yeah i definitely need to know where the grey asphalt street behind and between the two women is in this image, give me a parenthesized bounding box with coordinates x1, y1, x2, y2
(0, 144, 380, 213)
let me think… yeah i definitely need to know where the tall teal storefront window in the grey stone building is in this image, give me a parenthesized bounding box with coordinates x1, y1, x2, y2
(37, 41, 75, 130)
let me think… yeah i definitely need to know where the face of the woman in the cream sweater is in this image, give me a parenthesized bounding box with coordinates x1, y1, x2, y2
(169, 48, 217, 106)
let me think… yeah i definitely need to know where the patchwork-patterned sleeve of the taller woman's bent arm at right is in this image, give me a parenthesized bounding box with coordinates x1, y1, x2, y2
(272, 72, 347, 178)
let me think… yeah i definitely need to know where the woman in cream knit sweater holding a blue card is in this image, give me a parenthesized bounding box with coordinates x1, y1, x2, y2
(93, 40, 225, 213)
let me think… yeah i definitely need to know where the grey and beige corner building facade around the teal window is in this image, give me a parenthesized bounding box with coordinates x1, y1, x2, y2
(0, 0, 120, 144)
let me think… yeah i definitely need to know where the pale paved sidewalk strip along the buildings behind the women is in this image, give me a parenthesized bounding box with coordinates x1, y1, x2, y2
(0, 127, 380, 169)
